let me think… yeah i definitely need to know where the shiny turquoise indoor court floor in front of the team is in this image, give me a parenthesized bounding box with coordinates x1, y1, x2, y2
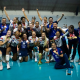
(0, 48, 80, 80)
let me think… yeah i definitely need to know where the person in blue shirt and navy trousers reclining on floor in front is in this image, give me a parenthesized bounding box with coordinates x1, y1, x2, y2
(46, 43, 73, 75)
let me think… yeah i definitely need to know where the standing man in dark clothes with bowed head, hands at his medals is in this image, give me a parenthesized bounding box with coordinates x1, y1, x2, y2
(67, 25, 78, 62)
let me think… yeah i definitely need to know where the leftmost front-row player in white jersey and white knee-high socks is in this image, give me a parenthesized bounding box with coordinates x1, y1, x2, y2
(0, 30, 11, 70)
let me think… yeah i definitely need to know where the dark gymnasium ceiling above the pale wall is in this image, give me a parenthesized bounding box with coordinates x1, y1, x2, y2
(0, 0, 80, 12)
